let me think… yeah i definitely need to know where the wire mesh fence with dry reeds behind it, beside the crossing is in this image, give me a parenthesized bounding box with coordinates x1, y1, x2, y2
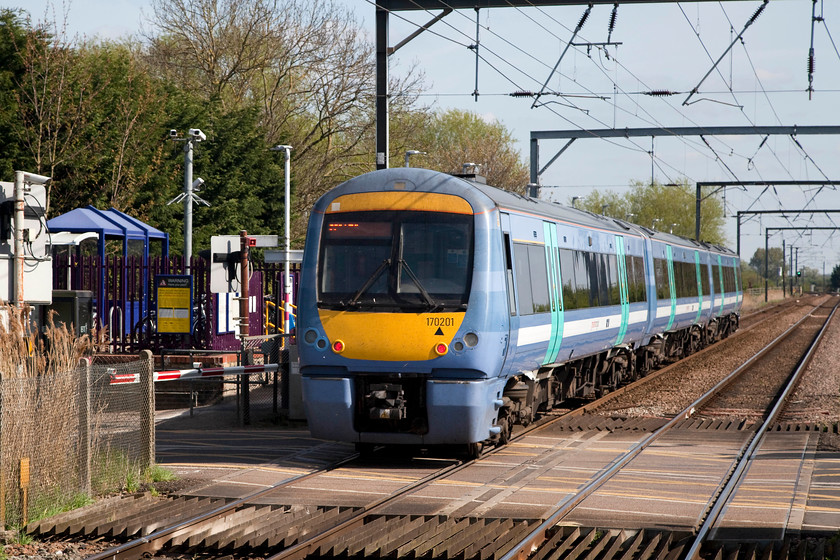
(0, 354, 154, 526)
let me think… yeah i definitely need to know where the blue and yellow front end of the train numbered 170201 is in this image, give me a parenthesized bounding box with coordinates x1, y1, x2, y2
(298, 168, 508, 445)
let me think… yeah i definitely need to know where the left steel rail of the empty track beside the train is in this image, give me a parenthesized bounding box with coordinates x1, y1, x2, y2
(500, 306, 820, 560)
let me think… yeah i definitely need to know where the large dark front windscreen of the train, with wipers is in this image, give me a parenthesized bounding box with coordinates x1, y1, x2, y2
(318, 211, 473, 312)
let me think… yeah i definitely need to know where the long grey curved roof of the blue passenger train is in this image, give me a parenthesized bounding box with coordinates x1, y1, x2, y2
(328, 167, 735, 255)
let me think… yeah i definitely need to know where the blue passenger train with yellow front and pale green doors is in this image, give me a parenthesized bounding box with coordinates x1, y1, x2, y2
(297, 168, 742, 455)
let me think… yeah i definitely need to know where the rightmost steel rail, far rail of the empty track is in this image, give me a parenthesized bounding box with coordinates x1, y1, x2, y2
(685, 303, 840, 560)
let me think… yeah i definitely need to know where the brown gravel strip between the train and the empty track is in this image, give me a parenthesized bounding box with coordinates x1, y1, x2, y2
(598, 298, 824, 417)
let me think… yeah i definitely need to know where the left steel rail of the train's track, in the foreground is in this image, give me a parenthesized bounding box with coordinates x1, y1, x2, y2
(87, 453, 359, 560)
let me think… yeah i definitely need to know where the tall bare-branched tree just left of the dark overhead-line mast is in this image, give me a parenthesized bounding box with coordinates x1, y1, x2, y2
(147, 0, 421, 240)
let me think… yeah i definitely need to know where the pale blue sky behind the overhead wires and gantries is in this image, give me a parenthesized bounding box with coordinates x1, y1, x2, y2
(0, 0, 840, 269)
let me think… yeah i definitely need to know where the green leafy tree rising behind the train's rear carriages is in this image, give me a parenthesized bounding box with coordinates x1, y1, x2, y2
(568, 179, 726, 245)
